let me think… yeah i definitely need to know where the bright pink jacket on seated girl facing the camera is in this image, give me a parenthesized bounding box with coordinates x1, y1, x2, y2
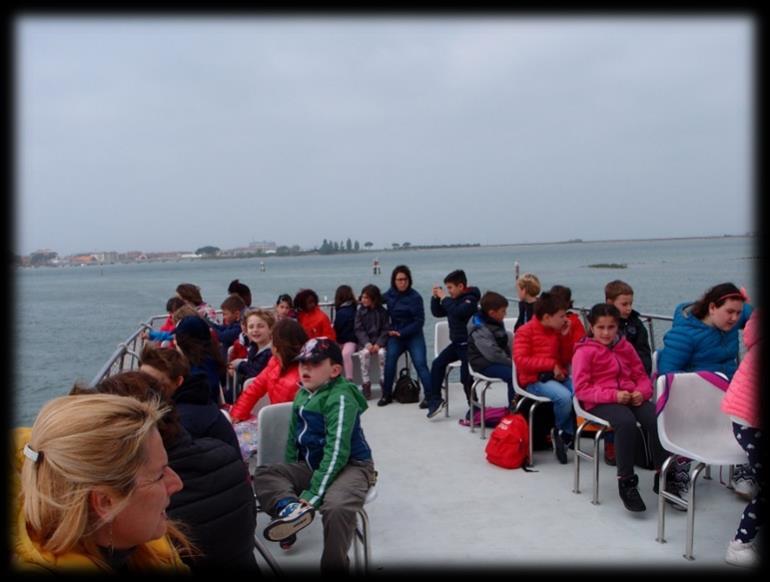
(572, 337, 652, 410)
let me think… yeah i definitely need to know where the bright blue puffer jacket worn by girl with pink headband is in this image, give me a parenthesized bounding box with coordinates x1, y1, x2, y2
(658, 303, 752, 378)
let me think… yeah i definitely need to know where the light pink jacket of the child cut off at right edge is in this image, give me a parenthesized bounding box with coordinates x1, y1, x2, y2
(722, 309, 762, 428)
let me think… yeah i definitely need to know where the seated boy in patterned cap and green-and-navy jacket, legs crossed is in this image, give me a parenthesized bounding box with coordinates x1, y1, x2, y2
(254, 337, 376, 572)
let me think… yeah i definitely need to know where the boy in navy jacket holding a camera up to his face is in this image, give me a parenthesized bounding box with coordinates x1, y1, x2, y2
(428, 269, 481, 418)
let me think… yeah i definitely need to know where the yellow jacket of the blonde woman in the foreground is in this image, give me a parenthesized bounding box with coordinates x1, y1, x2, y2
(11, 428, 189, 573)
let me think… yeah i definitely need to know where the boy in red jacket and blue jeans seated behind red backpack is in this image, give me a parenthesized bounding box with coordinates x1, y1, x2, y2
(513, 291, 575, 465)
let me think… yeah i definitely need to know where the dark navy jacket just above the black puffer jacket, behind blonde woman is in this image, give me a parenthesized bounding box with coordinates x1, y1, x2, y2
(171, 374, 241, 455)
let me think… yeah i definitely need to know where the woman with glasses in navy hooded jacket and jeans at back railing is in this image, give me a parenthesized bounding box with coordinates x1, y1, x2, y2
(377, 265, 430, 408)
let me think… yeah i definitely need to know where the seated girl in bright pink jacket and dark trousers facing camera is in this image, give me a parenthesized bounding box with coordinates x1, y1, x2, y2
(572, 303, 668, 511)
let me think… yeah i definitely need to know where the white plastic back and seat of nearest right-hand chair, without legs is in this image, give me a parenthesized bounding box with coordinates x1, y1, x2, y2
(656, 372, 746, 465)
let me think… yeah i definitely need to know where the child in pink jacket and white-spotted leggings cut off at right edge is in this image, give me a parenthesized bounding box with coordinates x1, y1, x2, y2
(722, 309, 765, 566)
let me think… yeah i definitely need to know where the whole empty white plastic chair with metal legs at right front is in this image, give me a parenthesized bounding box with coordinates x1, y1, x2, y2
(655, 372, 746, 560)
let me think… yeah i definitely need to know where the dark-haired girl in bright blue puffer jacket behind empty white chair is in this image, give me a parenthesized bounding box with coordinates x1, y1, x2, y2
(658, 283, 756, 508)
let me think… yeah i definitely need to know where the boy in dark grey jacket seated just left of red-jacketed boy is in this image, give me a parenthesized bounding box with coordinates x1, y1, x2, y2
(468, 291, 514, 410)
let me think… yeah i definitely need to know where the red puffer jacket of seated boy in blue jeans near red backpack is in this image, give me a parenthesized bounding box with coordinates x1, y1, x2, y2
(513, 317, 574, 388)
